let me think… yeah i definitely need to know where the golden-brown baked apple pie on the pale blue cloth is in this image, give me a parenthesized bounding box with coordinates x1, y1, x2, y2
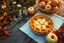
(29, 14, 54, 34)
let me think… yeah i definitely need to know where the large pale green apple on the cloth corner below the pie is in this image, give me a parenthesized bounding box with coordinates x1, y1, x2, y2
(46, 33, 58, 43)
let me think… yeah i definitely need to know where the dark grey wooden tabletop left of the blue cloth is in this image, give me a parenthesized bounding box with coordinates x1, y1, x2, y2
(0, 18, 37, 43)
